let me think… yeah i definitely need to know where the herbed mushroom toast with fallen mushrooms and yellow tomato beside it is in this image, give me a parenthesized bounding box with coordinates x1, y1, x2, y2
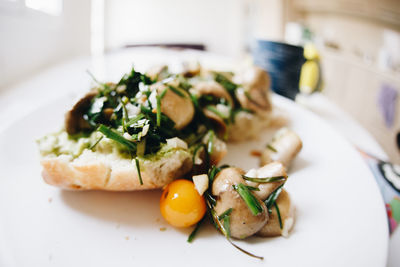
(38, 65, 301, 260)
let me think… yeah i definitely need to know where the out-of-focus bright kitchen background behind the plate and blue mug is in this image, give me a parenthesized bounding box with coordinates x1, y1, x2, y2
(0, 0, 400, 163)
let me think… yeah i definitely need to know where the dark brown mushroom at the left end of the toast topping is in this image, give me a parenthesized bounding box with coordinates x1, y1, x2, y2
(65, 91, 97, 134)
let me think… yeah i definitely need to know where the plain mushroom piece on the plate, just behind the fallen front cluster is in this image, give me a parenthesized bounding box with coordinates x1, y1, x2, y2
(260, 128, 303, 168)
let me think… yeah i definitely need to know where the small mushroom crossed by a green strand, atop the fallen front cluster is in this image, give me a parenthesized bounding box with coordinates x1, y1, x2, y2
(246, 162, 287, 201)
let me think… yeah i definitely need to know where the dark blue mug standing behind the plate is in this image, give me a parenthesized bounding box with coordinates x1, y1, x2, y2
(252, 40, 305, 100)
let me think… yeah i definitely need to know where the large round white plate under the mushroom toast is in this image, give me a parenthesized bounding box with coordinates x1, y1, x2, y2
(0, 93, 388, 267)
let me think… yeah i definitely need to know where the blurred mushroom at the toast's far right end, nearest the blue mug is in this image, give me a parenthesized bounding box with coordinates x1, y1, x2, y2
(236, 67, 272, 113)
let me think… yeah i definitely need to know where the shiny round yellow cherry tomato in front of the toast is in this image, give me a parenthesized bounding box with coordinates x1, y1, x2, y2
(160, 180, 206, 227)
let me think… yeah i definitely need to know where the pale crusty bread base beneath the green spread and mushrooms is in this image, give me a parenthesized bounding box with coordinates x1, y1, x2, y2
(41, 149, 193, 191)
